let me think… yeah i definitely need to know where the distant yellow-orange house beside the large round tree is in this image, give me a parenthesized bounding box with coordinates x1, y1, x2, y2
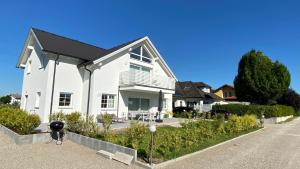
(214, 84, 237, 102)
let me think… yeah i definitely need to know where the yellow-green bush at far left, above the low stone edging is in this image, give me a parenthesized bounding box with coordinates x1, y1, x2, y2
(0, 106, 41, 134)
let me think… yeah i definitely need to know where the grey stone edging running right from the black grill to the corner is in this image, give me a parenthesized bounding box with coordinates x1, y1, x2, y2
(66, 132, 137, 161)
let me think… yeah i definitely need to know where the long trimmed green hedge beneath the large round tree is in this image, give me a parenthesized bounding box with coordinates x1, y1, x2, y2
(212, 104, 295, 118)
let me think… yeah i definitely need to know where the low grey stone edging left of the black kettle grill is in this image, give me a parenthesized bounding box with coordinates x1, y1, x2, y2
(0, 124, 50, 145)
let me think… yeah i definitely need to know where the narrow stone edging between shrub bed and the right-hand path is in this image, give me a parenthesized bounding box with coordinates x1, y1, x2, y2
(135, 128, 264, 169)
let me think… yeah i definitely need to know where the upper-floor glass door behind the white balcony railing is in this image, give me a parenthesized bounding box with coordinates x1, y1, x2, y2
(129, 64, 150, 86)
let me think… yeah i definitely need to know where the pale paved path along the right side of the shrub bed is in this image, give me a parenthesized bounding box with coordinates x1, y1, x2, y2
(165, 118, 300, 169)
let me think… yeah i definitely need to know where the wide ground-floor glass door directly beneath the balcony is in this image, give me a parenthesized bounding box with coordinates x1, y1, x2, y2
(128, 98, 150, 111)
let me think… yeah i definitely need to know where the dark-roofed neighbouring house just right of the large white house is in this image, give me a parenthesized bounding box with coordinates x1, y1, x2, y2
(173, 81, 223, 109)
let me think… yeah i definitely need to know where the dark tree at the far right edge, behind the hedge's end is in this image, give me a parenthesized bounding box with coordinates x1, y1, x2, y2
(278, 89, 300, 112)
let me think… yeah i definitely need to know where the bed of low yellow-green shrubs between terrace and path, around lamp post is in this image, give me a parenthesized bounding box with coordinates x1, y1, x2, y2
(104, 115, 259, 163)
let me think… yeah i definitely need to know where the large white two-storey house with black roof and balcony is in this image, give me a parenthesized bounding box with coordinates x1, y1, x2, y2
(17, 28, 176, 122)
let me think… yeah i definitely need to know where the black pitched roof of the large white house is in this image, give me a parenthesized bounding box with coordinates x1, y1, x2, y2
(32, 28, 140, 62)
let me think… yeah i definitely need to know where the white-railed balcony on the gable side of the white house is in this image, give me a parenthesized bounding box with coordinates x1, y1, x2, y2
(120, 71, 175, 91)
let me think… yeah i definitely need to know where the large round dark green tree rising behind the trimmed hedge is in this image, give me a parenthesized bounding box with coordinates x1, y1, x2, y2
(234, 50, 291, 104)
